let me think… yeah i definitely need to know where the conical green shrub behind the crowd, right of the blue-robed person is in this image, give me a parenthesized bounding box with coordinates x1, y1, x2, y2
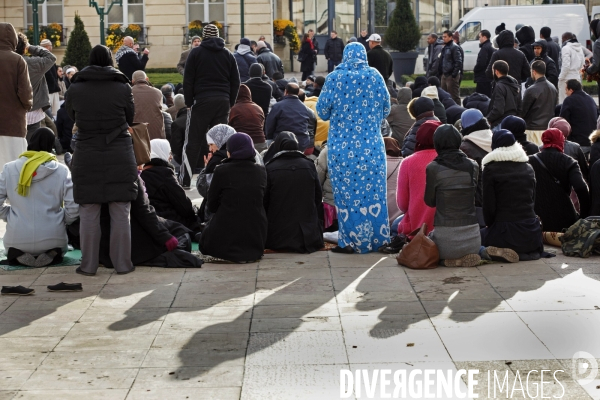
(384, 0, 421, 53)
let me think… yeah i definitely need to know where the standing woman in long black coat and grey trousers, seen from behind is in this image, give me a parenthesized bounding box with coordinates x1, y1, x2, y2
(66, 45, 138, 276)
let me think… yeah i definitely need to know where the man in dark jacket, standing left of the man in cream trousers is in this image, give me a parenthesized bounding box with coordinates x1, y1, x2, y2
(486, 60, 521, 127)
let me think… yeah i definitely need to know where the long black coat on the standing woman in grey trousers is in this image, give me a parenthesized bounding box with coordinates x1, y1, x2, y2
(66, 65, 138, 204)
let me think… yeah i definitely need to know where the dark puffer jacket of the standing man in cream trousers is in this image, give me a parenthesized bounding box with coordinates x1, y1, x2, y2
(521, 77, 558, 131)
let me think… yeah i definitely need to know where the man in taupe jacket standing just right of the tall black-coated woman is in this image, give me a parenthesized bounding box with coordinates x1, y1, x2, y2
(131, 71, 167, 140)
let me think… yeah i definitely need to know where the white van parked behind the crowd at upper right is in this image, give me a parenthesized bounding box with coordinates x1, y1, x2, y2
(451, 4, 591, 71)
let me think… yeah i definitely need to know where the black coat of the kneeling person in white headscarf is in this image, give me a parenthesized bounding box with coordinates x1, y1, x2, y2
(141, 158, 198, 230)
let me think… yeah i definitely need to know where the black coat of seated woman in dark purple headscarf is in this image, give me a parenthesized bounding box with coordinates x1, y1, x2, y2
(200, 159, 267, 262)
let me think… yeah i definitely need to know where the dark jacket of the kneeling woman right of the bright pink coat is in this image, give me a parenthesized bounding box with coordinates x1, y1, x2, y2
(425, 160, 479, 227)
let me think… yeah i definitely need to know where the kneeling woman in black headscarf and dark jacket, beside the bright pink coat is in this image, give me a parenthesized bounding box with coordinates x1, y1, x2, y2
(425, 124, 481, 267)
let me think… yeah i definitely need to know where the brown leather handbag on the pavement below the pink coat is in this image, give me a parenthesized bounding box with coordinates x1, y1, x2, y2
(396, 223, 440, 269)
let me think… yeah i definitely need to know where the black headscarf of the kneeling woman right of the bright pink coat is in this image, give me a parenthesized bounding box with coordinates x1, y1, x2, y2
(433, 124, 473, 179)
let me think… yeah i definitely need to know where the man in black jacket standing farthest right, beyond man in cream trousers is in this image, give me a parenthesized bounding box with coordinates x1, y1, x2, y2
(560, 79, 598, 155)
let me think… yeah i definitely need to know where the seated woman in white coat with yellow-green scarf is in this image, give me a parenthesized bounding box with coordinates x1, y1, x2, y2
(0, 128, 79, 267)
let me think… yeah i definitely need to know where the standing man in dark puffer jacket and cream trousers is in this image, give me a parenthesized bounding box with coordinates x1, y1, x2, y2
(521, 60, 558, 146)
